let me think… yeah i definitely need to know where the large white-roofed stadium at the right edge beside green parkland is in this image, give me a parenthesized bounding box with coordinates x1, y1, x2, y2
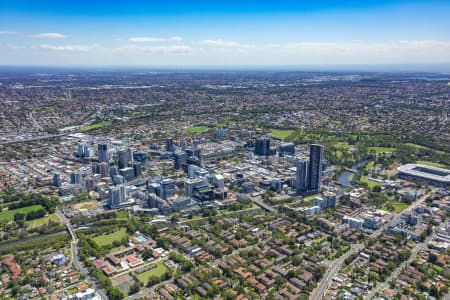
(398, 164, 450, 187)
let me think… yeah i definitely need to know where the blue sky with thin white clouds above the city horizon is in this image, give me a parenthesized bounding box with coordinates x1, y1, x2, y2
(0, 0, 450, 67)
